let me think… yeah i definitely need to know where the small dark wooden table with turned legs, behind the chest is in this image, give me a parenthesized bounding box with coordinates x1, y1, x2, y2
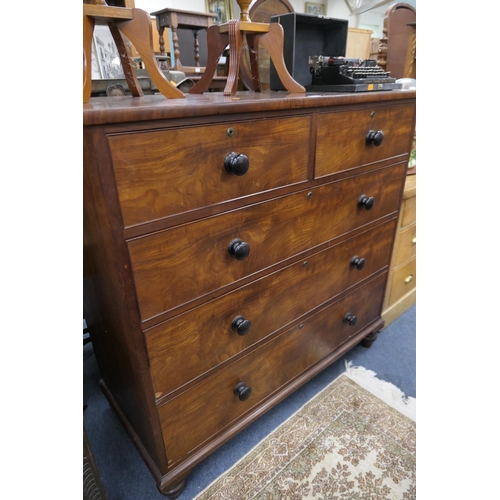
(151, 8, 217, 73)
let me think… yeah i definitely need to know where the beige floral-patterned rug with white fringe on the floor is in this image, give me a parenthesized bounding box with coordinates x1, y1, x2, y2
(195, 364, 416, 500)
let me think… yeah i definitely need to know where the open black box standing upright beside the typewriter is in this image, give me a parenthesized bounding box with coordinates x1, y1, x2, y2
(270, 12, 349, 90)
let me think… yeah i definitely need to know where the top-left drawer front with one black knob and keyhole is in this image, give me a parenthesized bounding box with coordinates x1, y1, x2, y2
(108, 116, 311, 227)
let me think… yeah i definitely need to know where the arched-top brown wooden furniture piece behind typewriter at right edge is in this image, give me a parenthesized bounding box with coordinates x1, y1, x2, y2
(377, 3, 417, 78)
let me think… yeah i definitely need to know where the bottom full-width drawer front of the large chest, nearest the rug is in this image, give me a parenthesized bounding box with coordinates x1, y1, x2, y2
(159, 274, 386, 465)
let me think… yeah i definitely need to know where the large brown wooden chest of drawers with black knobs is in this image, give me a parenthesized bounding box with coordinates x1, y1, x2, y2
(83, 91, 415, 498)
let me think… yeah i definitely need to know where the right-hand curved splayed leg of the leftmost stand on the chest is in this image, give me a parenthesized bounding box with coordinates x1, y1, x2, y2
(116, 9, 185, 99)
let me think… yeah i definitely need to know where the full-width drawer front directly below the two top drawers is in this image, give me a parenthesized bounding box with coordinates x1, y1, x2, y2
(129, 164, 406, 321)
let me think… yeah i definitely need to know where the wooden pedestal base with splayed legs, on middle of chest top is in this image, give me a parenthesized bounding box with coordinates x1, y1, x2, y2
(189, 0, 306, 96)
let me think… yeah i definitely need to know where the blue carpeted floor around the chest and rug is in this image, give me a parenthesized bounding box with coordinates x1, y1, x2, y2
(83, 306, 416, 500)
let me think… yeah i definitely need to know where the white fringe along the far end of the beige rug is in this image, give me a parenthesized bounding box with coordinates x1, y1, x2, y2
(345, 360, 417, 422)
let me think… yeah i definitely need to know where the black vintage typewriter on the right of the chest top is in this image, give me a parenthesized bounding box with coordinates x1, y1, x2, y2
(306, 56, 402, 92)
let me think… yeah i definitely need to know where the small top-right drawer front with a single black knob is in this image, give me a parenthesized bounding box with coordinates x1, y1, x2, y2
(314, 105, 415, 178)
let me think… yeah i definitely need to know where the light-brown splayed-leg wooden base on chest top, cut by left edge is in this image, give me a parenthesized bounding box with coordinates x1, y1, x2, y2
(83, 0, 185, 103)
